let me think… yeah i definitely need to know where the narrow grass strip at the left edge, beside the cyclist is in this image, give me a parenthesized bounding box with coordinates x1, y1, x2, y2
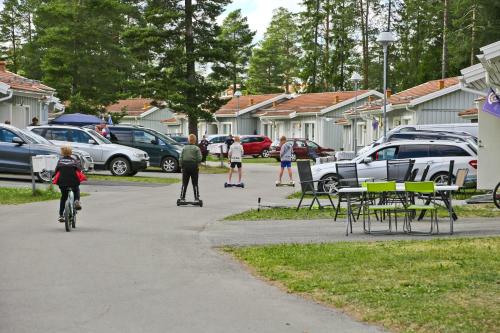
(0, 187, 88, 205)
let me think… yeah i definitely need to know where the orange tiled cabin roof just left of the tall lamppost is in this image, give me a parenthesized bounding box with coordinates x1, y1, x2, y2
(266, 90, 368, 113)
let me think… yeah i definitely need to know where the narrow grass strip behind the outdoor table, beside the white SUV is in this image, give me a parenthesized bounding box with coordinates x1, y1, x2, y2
(224, 201, 500, 221)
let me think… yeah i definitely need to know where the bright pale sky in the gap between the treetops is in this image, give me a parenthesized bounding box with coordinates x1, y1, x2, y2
(220, 0, 302, 42)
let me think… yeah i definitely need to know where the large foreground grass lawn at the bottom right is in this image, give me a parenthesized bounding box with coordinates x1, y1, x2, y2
(228, 238, 500, 333)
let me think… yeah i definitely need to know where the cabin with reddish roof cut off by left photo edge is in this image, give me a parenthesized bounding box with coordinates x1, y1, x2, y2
(0, 61, 64, 128)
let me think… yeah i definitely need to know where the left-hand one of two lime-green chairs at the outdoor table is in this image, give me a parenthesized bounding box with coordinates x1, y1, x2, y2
(363, 181, 398, 234)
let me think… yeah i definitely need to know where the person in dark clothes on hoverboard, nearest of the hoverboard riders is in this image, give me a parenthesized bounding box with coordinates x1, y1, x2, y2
(179, 134, 202, 201)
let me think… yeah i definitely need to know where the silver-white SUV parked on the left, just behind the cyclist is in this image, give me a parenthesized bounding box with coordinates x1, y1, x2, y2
(28, 125, 149, 176)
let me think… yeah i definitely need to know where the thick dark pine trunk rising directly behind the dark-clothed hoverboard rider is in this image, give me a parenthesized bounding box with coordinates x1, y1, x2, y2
(184, 0, 198, 135)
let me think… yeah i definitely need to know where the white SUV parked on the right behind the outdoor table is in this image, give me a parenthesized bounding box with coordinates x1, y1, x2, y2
(312, 141, 477, 190)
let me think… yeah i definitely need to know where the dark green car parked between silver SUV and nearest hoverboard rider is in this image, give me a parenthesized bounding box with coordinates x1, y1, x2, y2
(108, 125, 182, 172)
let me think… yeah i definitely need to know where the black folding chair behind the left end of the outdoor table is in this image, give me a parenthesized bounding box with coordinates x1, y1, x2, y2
(333, 163, 363, 221)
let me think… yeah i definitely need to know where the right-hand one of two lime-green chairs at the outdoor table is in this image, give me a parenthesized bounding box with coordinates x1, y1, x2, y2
(404, 181, 439, 235)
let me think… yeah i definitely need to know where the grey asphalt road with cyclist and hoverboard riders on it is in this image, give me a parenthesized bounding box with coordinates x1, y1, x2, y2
(0, 165, 379, 333)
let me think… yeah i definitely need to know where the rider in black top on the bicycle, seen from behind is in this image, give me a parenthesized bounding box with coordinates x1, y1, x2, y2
(55, 146, 82, 223)
